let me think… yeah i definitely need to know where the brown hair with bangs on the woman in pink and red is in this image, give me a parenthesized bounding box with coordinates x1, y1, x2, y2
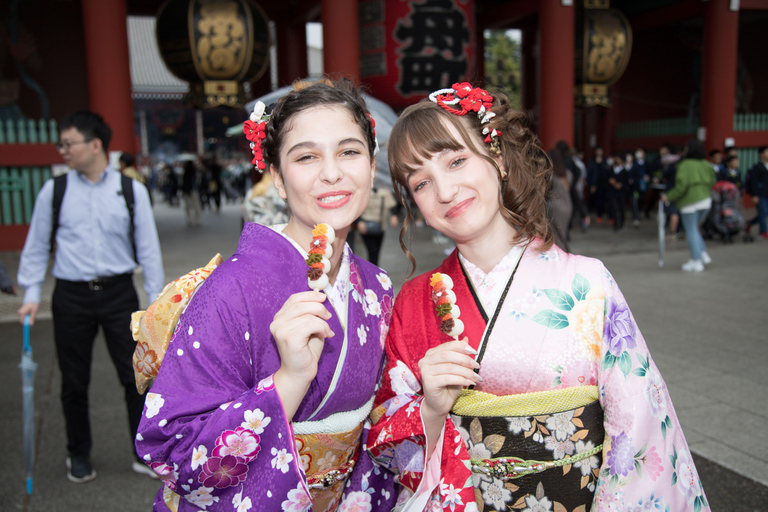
(388, 87, 554, 276)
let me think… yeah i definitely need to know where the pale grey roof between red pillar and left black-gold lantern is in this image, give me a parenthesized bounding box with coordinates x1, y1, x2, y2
(128, 16, 189, 99)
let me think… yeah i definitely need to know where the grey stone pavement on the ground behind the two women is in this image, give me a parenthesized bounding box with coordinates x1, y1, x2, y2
(0, 198, 768, 512)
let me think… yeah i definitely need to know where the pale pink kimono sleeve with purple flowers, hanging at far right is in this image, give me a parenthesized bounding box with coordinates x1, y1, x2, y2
(593, 265, 709, 512)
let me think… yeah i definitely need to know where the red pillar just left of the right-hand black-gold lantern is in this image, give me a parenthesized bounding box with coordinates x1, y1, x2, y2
(538, 0, 575, 149)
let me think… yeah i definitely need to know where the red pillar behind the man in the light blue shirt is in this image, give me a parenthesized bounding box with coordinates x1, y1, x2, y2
(82, 0, 136, 153)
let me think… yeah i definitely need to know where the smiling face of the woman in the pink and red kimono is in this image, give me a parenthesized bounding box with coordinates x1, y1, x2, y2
(407, 124, 512, 245)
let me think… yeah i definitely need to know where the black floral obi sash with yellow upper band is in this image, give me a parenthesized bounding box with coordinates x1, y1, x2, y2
(451, 386, 605, 512)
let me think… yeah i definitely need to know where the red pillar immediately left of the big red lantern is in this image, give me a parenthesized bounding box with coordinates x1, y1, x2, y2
(320, 0, 360, 82)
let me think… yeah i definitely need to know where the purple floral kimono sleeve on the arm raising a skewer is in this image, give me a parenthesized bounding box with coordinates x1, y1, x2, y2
(136, 268, 311, 511)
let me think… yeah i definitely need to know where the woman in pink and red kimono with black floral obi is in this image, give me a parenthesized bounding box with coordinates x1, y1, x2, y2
(367, 83, 709, 512)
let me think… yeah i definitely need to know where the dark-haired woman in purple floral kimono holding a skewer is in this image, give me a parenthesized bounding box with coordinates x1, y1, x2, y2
(136, 80, 395, 512)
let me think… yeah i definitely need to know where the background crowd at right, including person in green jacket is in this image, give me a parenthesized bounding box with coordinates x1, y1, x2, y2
(549, 139, 768, 272)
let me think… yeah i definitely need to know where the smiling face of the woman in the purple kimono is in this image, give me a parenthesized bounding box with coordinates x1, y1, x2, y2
(270, 107, 376, 243)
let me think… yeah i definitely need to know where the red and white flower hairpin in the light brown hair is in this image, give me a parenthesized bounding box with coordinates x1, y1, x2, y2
(429, 82, 501, 155)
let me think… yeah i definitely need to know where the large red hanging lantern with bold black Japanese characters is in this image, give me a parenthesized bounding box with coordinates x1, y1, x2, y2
(360, 0, 474, 107)
